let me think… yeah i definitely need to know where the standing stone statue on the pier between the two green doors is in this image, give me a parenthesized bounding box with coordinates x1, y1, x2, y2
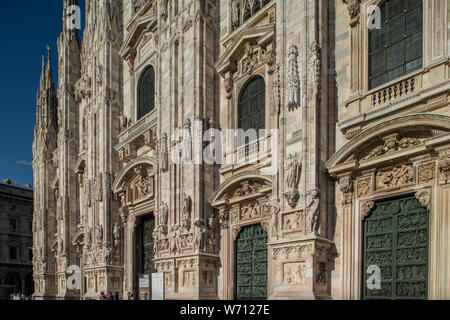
(284, 153, 302, 208)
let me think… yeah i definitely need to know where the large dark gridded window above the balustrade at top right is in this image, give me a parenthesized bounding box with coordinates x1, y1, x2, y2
(369, 0, 423, 89)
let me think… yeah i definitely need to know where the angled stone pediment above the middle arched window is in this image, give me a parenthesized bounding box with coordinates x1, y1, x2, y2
(216, 24, 275, 74)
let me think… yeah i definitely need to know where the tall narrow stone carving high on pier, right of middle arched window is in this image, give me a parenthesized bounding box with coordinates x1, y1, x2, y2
(286, 45, 301, 111)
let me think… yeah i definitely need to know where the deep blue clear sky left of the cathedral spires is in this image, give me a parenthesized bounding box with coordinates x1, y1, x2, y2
(0, 0, 84, 188)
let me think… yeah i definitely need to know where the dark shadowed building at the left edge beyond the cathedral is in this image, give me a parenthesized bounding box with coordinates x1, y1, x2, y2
(0, 179, 34, 300)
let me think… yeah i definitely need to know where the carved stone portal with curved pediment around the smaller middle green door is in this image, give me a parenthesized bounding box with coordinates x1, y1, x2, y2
(210, 171, 274, 299)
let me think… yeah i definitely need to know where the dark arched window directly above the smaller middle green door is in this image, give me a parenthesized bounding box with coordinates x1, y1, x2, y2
(238, 76, 266, 145)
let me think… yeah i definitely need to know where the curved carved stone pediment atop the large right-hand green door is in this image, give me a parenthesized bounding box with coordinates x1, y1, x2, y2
(326, 113, 450, 176)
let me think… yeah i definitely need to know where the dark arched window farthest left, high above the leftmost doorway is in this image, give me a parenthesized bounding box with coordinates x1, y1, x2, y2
(137, 66, 155, 120)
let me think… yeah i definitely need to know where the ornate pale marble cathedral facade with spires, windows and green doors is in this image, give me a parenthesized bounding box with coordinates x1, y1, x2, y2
(33, 0, 450, 300)
